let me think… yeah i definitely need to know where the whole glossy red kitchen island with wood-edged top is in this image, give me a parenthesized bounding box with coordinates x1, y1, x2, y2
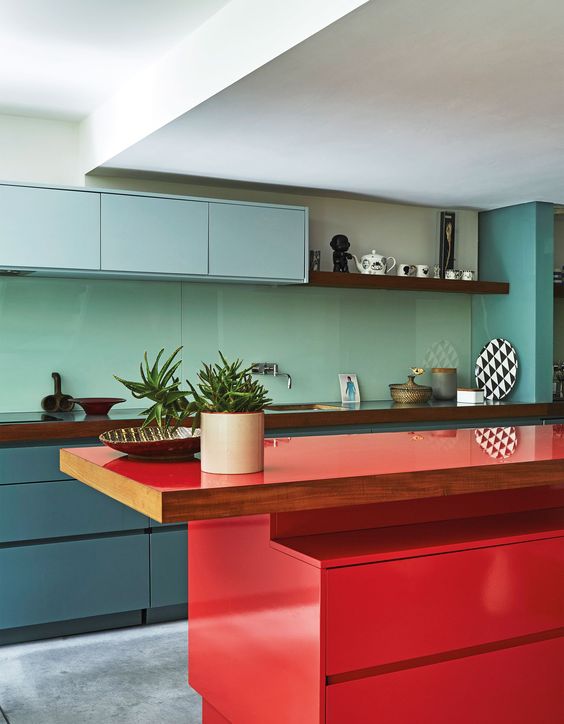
(61, 425, 564, 724)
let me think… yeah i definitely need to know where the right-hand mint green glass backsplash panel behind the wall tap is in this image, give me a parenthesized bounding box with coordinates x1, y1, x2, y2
(182, 284, 470, 402)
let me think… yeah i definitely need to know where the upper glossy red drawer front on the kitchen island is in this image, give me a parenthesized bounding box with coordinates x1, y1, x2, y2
(326, 537, 564, 674)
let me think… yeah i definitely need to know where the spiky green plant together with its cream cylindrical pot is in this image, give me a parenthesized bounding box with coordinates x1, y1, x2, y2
(187, 352, 271, 474)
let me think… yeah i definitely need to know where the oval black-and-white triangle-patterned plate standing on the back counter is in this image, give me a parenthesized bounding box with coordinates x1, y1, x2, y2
(474, 339, 519, 400)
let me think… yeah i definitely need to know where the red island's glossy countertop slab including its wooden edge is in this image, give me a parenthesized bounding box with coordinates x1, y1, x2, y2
(61, 425, 564, 523)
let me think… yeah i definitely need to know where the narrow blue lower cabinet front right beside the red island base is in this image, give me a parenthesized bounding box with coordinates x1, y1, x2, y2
(150, 527, 188, 608)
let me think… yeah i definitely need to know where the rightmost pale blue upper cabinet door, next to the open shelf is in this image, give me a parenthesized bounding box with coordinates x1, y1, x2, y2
(209, 203, 307, 282)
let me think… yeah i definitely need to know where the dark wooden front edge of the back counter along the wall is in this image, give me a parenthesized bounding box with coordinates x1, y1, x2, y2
(0, 402, 564, 443)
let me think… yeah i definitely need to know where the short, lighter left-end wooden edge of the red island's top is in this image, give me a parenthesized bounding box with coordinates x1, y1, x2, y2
(59, 449, 163, 522)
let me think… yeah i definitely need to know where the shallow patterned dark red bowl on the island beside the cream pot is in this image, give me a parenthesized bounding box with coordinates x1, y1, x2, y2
(100, 427, 200, 460)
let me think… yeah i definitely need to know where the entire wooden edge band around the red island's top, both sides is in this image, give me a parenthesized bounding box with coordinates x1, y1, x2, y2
(61, 450, 564, 523)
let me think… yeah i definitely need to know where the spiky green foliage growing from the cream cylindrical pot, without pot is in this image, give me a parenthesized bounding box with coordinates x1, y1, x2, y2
(186, 352, 272, 427)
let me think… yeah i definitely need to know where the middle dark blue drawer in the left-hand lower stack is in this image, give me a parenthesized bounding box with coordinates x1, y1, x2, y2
(0, 480, 149, 543)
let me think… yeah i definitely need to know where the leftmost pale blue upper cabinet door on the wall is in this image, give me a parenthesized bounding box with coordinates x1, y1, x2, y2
(0, 185, 100, 270)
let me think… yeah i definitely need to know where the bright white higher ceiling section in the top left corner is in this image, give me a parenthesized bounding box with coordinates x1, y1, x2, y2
(0, 0, 229, 120)
